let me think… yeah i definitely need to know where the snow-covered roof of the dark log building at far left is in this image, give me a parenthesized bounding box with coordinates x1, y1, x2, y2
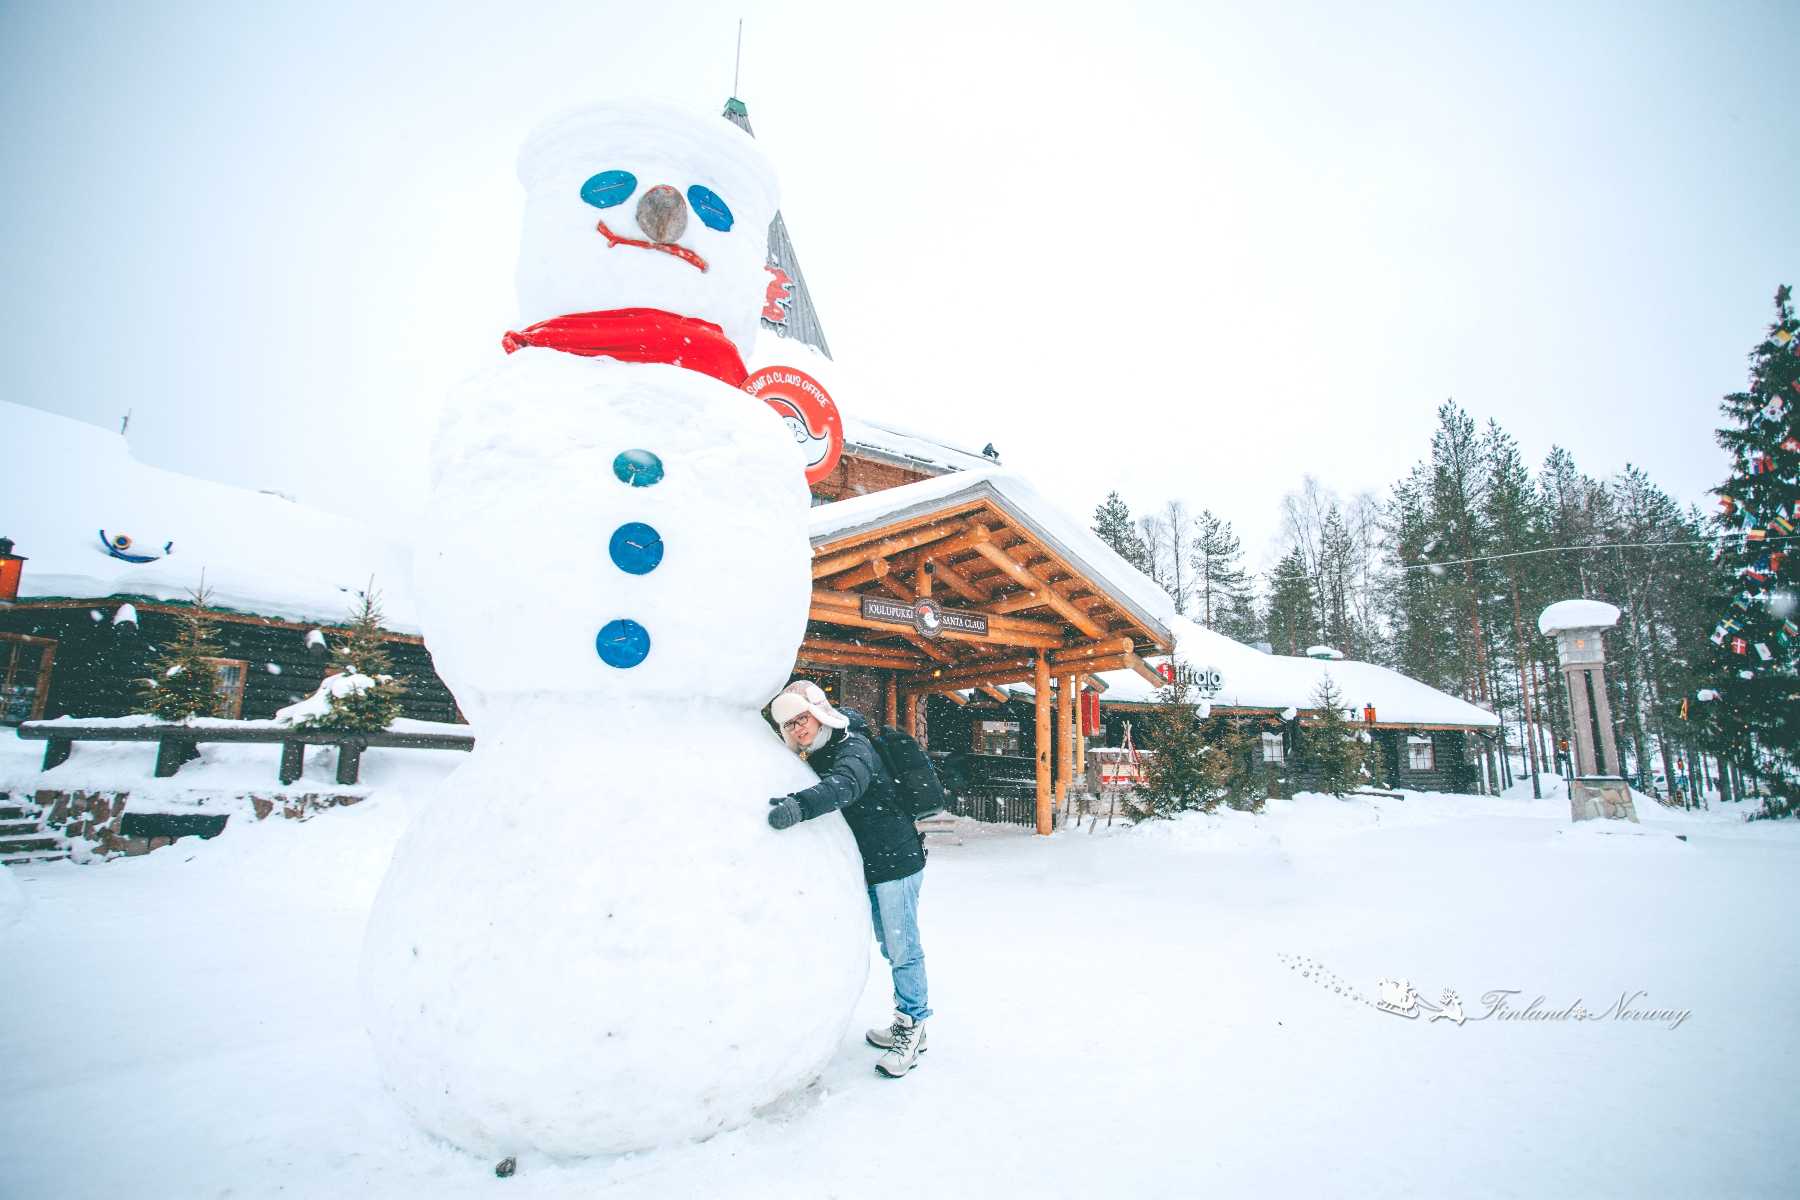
(0, 401, 418, 633)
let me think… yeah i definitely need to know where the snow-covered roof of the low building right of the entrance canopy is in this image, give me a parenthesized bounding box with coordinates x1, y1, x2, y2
(1102, 617, 1499, 729)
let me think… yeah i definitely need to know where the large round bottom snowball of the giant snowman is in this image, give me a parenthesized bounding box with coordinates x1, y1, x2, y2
(362, 702, 871, 1159)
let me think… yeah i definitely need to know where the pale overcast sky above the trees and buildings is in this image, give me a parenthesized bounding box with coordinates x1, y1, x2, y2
(0, 0, 1800, 567)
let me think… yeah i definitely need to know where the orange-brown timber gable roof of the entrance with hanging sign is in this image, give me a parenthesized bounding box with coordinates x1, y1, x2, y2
(799, 488, 1172, 694)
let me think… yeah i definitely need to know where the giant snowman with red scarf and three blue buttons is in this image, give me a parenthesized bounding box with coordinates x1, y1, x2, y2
(362, 101, 869, 1157)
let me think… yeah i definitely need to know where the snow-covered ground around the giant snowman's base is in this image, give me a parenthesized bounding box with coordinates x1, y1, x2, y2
(0, 736, 1800, 1200)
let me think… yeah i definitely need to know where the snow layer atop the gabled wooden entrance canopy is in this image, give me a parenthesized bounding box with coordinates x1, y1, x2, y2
(808, 464, 1173, 653)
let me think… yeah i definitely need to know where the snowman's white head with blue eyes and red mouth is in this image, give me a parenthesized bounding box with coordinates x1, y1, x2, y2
(517, 99, 781, 358)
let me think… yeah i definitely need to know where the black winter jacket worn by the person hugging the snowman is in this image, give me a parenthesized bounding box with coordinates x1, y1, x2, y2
(794, 709, 925, 883)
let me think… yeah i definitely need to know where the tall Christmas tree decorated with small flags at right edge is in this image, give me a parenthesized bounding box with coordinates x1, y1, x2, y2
(1703, 286, 1800, 811)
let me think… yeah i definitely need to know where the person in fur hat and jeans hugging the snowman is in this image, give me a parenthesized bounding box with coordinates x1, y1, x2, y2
(769, 680, 931, 1079)
